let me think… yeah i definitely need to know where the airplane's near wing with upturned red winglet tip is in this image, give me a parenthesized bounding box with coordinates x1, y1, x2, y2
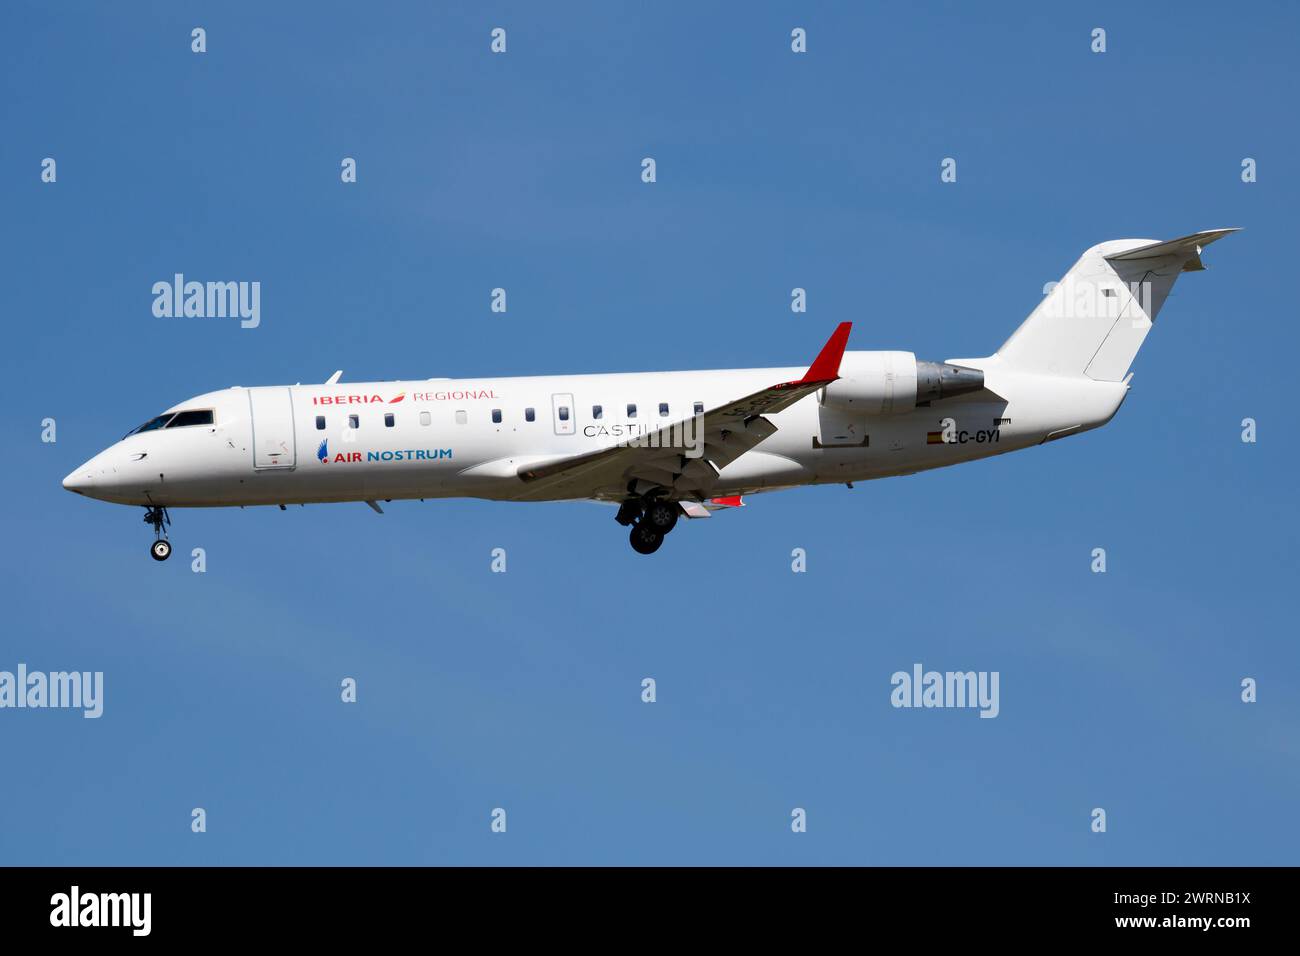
(517, 323, 853, 501)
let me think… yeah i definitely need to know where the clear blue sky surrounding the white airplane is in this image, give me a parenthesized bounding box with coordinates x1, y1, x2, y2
(0, 1, 1300, 865)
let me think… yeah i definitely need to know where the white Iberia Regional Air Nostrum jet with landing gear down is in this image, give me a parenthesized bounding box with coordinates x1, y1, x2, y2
(62, 229, 1238, 561)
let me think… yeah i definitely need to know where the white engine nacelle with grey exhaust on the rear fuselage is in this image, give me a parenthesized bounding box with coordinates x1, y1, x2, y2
(822, 352, 984, 415)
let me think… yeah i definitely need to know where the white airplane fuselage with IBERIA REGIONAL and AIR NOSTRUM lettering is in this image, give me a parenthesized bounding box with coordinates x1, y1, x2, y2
(64, 352, 1127, 507)
